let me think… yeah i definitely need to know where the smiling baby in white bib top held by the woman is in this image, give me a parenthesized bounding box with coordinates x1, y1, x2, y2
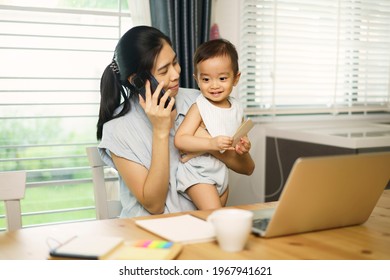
(175, 39, 246, 209)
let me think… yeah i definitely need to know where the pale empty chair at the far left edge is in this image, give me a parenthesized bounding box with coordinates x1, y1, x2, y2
(0, 171, 26, 231)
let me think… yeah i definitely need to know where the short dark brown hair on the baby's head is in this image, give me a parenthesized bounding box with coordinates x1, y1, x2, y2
(194, 39, 239, 75)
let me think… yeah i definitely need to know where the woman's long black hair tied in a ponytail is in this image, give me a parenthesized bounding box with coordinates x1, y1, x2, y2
(96, 26, 172, 140)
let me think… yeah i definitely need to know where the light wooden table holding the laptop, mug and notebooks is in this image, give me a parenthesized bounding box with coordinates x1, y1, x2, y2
(0, 190, 390, 260)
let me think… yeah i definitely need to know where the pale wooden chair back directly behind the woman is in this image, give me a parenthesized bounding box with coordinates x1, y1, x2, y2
(86, 147, 122, 220)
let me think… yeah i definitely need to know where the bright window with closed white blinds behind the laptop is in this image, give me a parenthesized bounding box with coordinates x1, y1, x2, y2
(239, 0, 390, 116)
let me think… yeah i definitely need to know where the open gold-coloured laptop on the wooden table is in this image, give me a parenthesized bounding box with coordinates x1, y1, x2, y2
(252, 152, 390, 238)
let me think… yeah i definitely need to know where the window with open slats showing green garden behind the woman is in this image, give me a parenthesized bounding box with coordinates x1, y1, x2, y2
(0, 0, 132, 228)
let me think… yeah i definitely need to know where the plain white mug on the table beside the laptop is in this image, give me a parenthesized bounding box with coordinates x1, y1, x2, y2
(207, 209, 253, 252)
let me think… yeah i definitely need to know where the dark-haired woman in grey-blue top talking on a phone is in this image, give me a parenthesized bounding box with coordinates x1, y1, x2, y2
(97, 26, 254, 217)
